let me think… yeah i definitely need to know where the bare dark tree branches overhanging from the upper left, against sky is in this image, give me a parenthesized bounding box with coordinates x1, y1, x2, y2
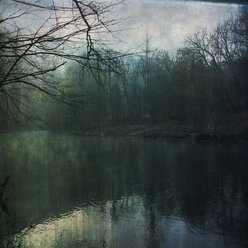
(0, 0, 122, 124)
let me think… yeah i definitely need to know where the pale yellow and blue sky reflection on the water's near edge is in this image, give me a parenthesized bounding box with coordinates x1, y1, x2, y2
(17, 196, 238, 248)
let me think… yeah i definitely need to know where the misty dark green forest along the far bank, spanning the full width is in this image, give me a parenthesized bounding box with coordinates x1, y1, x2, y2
(0, 1, 248, 139)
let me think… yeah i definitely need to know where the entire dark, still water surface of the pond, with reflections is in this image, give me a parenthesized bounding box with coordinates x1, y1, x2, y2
(0, 132, 248, 248)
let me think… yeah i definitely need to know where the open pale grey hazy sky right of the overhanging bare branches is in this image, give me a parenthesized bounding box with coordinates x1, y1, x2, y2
(116, 0, 238, 50)
